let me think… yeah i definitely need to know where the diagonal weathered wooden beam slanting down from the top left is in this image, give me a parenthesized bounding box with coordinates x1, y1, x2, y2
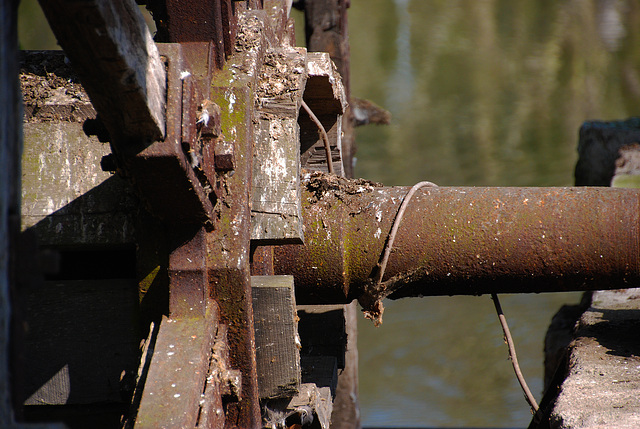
(40, 0, 166, 143)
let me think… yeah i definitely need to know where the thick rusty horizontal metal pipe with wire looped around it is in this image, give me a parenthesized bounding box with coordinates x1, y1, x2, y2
(275, 179, 640, 303)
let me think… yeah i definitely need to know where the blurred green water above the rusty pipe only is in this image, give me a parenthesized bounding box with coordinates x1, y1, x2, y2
(349, 0, 640, 186)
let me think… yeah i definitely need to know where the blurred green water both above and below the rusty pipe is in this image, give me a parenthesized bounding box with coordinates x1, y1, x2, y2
(349, 0, 640, 427)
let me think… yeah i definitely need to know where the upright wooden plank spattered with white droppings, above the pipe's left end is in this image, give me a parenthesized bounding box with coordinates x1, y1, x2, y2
(251, 48, 307, 244)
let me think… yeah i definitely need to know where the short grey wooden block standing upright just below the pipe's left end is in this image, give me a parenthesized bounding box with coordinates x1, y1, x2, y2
(251, 276, 301, 399)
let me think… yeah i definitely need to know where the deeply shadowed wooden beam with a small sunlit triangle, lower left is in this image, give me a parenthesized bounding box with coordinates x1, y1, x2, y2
(19, 279, 139, 405)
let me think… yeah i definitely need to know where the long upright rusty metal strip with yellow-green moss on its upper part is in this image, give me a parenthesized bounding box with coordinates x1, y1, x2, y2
(202, 11, 282, 422)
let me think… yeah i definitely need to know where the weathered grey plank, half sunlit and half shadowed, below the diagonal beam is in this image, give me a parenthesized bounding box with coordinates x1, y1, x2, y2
(22, 122, 139, 246)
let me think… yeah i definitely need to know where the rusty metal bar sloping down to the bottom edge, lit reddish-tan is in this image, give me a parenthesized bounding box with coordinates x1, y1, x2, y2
(136, 222, 227, 428)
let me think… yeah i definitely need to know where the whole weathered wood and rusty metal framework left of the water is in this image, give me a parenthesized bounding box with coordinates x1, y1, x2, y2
(3, 0, 357, 428)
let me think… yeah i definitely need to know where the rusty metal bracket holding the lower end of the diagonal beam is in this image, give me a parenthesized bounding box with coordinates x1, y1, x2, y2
(127, 43, 221, 225)
